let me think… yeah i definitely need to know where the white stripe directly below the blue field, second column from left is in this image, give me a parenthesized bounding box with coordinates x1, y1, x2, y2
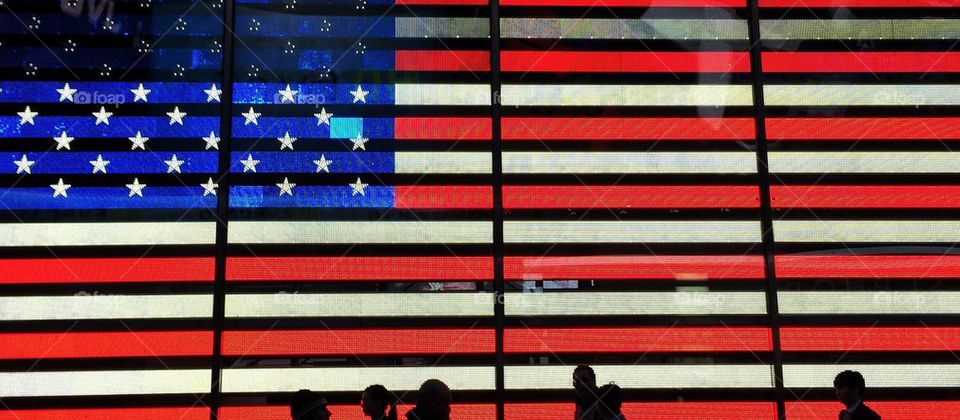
(227, 221, 493, 244)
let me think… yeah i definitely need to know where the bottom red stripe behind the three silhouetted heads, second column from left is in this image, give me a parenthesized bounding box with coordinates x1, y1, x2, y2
(218, 404, 497, 420)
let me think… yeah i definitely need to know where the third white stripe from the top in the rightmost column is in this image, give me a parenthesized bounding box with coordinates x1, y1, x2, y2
(770, 151, 960, 174)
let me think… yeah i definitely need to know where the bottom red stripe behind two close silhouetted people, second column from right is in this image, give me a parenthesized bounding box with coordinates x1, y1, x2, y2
(504, 402, 776, 420)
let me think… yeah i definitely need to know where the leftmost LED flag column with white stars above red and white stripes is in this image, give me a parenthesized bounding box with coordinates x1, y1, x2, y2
(0, 0, 223, 419)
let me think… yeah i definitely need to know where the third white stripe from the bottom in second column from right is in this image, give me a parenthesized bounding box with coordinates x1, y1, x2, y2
(503, 220, 760, 243)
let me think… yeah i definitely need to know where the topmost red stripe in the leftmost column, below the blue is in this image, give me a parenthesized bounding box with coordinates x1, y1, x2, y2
(0, 258, 214, 284)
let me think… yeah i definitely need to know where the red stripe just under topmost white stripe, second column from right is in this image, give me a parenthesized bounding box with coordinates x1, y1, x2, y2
(500, 51, 750, 73)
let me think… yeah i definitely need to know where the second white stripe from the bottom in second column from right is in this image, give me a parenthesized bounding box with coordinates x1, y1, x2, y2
(504, 292, 767, 316)
